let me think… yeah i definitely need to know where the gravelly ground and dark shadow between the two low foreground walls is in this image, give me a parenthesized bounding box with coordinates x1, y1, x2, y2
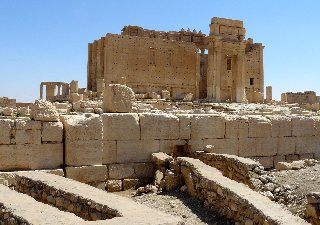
(117, 191, 234, 225)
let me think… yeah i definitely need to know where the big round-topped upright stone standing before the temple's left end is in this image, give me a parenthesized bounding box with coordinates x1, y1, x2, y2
(103, 84, 135, 113)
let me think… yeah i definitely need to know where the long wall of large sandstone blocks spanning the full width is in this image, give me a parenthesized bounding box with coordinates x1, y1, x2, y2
(0, 113, 320, 191)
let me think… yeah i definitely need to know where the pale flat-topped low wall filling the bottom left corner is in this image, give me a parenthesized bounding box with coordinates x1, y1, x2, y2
(0, 185, 85, 225)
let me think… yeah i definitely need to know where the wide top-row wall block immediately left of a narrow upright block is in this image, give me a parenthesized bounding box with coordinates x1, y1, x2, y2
(139, 113, 179, 140)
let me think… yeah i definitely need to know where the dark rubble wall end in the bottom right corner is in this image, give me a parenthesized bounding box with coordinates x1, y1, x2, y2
(305, 192, 320, 225)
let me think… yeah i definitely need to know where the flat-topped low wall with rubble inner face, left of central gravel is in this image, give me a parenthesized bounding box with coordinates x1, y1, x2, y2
(16, 171, 180, 225)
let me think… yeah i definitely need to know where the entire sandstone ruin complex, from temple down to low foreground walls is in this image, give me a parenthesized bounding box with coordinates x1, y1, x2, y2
(0, 18, 320, 225)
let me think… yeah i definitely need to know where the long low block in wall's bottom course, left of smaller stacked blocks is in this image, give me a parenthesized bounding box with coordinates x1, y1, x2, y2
(65, 165, 108, 183)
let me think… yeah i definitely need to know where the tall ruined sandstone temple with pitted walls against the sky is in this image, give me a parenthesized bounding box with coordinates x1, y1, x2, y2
(87, 17, 264, 102)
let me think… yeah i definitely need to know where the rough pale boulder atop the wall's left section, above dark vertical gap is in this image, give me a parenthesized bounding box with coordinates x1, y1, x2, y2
(30, 100, 59, 122)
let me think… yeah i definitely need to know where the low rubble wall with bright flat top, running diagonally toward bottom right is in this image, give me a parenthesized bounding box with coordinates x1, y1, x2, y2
(177, 157, 308, 225)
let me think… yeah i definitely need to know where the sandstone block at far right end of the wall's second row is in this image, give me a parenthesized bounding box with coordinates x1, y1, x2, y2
(295, 136, 320, 154)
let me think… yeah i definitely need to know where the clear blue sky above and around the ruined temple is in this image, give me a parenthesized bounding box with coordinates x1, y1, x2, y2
(0, 0, 320, 101)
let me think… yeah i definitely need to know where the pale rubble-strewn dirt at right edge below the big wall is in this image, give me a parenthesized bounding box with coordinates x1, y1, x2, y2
(271, 163, 320, 218)
